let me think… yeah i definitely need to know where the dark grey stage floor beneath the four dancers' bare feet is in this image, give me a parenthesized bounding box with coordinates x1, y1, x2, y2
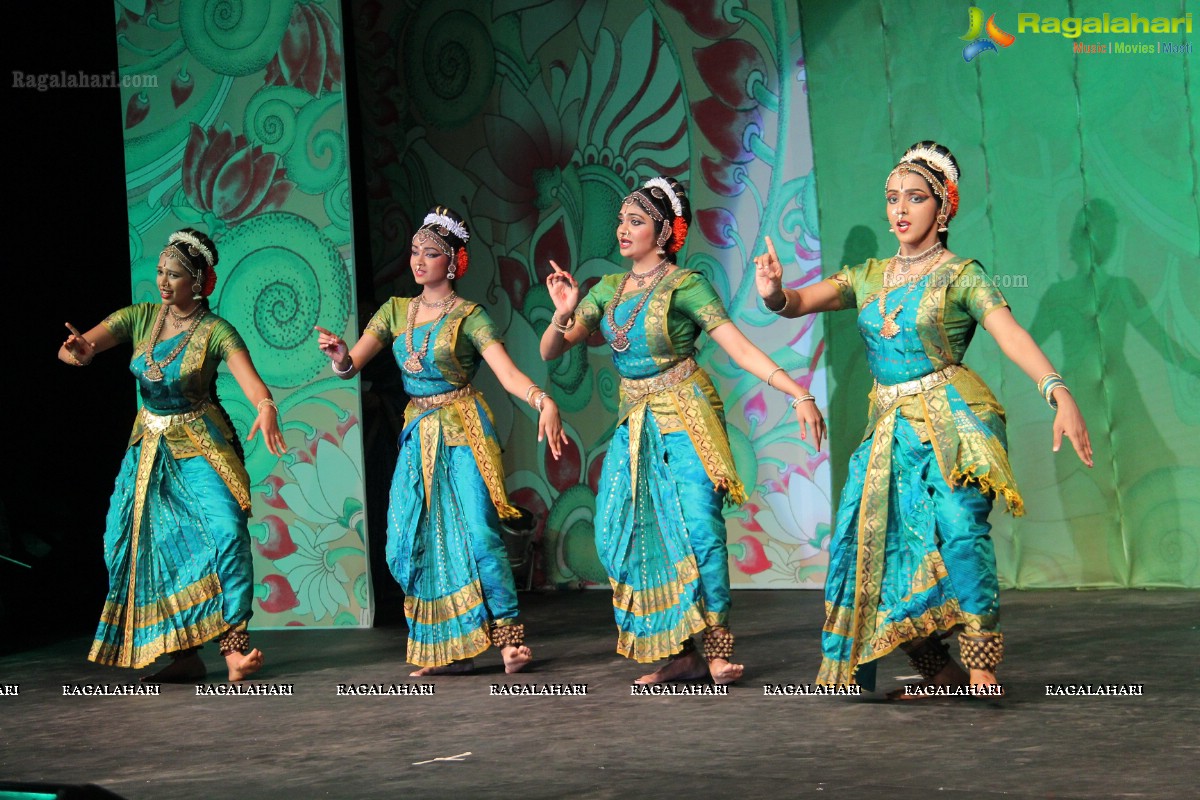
(0, 591, 1200, 800)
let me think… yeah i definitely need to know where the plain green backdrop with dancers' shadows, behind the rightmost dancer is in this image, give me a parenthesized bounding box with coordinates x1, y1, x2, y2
(800, 0, 1200, 588)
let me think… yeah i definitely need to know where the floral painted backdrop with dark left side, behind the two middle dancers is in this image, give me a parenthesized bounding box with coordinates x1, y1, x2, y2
(352, 0, 830, 588)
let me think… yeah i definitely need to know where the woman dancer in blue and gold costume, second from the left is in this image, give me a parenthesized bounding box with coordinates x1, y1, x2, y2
(317, 206, 566, 675)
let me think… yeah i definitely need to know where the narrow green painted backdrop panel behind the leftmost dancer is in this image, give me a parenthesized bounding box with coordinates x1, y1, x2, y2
(115, 0, 372, 628)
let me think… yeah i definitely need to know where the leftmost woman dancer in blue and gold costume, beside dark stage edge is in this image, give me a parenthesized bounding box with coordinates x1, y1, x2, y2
(59, 228, 287, 681)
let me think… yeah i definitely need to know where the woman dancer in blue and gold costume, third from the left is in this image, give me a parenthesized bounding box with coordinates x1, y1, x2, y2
(541, 178, 824, 684)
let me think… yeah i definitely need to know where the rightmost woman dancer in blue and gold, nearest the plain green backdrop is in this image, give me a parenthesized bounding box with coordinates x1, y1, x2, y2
(755, 142, 1092, 697)
